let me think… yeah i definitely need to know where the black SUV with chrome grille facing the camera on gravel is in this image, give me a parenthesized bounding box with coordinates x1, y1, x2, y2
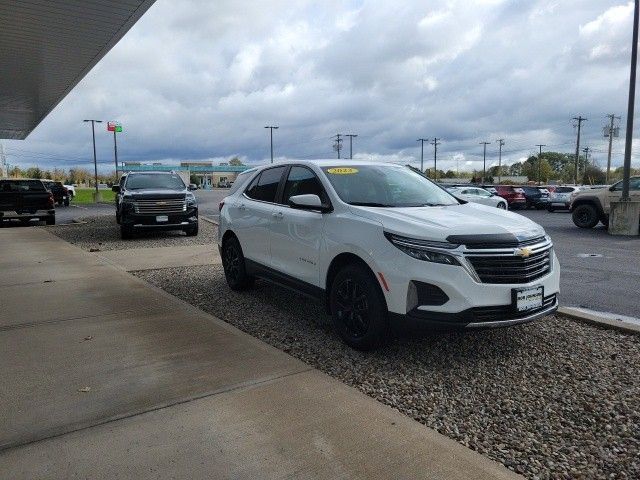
(112, 172, 198, 239)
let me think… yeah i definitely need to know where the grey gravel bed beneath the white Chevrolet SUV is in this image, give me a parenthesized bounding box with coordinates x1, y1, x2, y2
(136, 266, 640, 479)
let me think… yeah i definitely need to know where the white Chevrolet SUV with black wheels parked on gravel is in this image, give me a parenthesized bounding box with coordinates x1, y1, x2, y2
(218, 160, 560, 350)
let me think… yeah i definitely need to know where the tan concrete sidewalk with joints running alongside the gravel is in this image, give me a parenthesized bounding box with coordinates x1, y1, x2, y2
(0, 228, 520, 479)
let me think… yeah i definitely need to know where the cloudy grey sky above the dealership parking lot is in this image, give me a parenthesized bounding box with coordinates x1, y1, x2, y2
(3, 0, 640, 171)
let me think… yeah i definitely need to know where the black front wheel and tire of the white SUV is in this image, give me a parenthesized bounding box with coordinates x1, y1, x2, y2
(329, 264, 389, 351)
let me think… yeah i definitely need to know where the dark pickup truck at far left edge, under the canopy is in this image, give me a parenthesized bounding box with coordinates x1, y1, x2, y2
(0, 179, 56, 225)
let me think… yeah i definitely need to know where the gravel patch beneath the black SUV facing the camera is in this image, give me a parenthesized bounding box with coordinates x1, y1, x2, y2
(47, 215, 218, 252)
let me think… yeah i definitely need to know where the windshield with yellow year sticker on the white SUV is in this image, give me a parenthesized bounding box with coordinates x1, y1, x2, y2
(322, 165, 459, 207)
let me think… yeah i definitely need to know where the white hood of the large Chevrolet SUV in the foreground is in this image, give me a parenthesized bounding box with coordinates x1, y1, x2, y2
(349, 203, 545, 242)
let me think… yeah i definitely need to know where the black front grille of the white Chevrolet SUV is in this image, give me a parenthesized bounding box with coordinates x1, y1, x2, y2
(467, 247, 551, 283)
